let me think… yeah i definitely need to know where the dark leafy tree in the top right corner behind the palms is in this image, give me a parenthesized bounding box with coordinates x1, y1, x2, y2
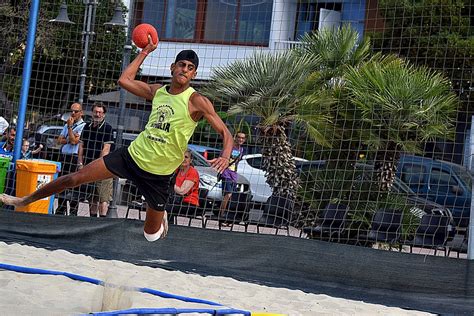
(370, 0, 474, 162)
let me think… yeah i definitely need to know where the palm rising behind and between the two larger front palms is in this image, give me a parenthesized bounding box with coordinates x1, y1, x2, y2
(295, 25, 370, 169)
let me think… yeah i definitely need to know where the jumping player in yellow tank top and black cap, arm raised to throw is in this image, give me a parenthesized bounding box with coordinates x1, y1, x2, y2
(0, 35, 233, 241)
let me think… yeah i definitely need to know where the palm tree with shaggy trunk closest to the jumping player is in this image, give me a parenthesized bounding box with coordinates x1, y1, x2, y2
(204, 51, 332, 198)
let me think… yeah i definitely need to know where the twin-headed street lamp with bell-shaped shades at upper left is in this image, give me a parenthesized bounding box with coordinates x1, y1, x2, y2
(50, 0, 127, 104)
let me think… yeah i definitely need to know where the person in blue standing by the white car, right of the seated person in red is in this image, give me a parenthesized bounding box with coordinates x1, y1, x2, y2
(219, 132, 246, 216)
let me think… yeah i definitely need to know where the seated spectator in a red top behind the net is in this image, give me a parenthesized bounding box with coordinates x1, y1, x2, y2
(174, 150, 199, 206)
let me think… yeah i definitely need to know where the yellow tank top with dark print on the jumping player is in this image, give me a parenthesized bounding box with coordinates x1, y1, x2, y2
(128, 86, 197, 175)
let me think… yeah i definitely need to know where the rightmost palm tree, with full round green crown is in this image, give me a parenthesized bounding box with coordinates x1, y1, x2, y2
(344, 56, 458, 191)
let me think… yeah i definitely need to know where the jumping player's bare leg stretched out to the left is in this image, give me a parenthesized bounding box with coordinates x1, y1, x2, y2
(0, 158, 114, 206)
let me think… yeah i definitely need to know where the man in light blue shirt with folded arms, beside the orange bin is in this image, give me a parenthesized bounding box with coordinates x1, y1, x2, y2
(56, 103, 86, 216)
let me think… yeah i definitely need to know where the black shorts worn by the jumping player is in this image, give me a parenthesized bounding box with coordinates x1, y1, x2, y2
(104, 147, 173, 211)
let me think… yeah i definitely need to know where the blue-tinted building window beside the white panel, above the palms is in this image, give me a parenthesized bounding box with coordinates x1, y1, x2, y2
(295, 2, 342, 39)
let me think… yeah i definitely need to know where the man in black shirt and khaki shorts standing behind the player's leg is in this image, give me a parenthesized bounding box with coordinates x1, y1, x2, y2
(78, 102, 114, 217)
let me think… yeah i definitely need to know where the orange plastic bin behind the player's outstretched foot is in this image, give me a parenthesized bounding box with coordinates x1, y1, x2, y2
(15, 160, 57, 214)
